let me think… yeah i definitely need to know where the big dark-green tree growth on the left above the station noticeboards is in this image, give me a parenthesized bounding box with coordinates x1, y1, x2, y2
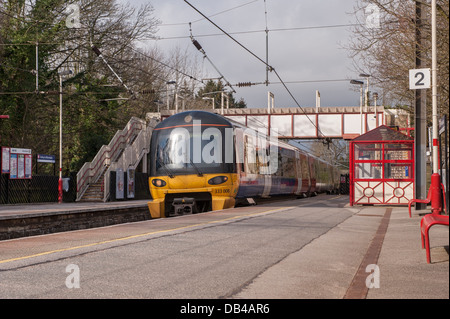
(0, 0, 158, 170)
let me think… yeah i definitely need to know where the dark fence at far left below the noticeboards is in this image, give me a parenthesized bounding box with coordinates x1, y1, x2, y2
(0, 174, 76, 204)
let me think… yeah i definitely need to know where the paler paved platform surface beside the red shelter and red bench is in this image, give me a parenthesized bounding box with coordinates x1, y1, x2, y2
(234, 205, 450, 300)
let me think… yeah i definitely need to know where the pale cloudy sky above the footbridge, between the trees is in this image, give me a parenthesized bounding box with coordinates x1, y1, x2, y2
(119, 0, 368, 108)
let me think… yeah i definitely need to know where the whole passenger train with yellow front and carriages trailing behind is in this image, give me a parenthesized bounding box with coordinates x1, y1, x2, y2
(148, 111, 340, 218)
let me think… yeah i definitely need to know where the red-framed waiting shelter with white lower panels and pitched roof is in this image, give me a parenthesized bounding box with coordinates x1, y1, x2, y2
(350, 125, 414, 206)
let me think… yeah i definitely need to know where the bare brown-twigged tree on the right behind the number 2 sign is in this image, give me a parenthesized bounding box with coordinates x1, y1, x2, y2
(348, 0, 449, 120)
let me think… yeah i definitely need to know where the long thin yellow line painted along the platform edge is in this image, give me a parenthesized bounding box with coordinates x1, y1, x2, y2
(0, 206, 296, 264)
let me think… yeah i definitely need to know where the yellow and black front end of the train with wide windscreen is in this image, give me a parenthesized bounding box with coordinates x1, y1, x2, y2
(148, 111, 239, 218)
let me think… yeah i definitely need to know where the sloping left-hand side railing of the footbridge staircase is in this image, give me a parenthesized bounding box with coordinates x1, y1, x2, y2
(77, 117, 145, 201)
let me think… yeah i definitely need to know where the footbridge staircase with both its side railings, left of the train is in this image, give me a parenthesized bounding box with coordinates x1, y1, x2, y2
(77, 114, 159, 202)
